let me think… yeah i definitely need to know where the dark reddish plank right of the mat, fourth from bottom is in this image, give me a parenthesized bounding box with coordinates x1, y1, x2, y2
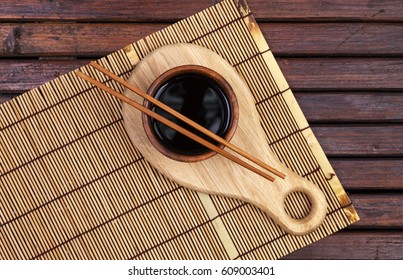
(312, 125, 403, 156)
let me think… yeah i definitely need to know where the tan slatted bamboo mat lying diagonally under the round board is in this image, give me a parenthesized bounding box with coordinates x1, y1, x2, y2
(0, 0, 359, 259)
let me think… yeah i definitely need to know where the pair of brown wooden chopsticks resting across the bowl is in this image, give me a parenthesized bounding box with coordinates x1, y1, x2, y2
(75, 61, 285, 182)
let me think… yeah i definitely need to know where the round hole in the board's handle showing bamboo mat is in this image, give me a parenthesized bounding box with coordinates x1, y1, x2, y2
(284, 192, 312, 219)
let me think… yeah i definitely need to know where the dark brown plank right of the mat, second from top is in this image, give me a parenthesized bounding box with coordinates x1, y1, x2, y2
(266, 22, 403, 56)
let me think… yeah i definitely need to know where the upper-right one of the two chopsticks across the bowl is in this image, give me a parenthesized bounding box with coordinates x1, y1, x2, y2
(90, 61, 285, 179)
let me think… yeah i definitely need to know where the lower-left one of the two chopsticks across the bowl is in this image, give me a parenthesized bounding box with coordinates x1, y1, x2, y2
(75, 70, 274, 182)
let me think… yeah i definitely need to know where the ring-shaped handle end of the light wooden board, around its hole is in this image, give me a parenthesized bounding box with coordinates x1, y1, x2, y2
(268, 180, 327, 235)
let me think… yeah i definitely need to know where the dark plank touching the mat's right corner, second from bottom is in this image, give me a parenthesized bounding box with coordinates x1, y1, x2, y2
(349, 192, 403, 229)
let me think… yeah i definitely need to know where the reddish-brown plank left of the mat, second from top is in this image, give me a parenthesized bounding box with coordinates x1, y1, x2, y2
(0, 23, 168, 57)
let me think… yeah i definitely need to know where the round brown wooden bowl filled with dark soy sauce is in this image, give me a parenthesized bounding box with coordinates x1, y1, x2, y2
(145, 66, 237, 161)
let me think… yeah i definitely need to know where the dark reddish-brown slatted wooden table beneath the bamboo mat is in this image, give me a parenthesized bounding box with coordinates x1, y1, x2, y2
(0, 0, 403, 259)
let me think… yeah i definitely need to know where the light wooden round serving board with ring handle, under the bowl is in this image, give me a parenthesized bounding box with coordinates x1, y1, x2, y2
(122, 44, 327, 235)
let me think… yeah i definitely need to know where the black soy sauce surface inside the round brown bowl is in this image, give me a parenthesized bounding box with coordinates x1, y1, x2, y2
(151, 73, 231, 155)
